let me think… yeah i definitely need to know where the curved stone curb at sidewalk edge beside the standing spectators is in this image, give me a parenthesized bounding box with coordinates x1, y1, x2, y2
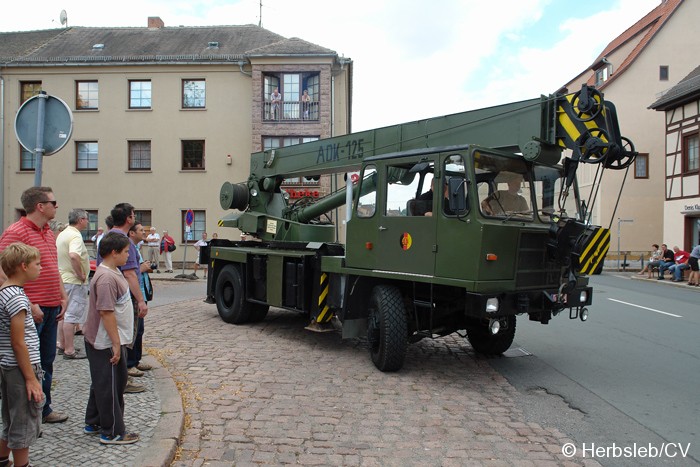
(134, 355, 185, 467)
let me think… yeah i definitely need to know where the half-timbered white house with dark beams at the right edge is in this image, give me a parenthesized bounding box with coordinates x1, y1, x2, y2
(650, 66, 700, 251)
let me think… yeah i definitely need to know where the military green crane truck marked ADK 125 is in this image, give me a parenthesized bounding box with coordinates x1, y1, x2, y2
(206, 86, 637, 371)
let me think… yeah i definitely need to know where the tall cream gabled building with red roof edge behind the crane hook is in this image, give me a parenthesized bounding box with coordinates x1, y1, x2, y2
(564, 0, 700, 253)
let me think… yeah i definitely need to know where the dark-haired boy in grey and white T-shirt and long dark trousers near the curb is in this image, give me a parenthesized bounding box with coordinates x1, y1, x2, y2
(83, 233, 139, 444)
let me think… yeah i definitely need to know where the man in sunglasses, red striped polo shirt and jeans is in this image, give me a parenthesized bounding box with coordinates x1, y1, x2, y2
(0, 186, 68, 423)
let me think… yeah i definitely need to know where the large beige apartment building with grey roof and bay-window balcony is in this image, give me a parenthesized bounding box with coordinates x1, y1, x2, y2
(0, 17, 352, 262)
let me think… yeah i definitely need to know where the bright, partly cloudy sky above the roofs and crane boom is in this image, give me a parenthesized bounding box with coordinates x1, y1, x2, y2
(0, 0, 661, 131)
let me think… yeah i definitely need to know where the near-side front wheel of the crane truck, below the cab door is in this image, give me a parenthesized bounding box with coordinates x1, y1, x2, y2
(367, 285, 408, 371)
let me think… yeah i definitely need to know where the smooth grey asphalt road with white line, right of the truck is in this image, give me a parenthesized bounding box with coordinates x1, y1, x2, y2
(491, 274, 700, 465)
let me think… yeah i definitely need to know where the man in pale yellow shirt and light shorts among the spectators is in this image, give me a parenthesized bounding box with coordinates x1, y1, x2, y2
(56, 209, 90, 359)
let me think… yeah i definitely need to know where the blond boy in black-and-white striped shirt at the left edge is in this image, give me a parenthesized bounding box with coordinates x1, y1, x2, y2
(0, 242, 45, 467)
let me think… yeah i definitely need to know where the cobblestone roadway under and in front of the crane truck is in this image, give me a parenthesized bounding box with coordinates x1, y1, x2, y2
(146, 299, 598, 467)
